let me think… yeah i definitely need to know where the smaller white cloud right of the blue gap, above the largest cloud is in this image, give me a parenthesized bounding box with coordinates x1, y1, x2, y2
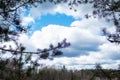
(70, 17, 114, 35)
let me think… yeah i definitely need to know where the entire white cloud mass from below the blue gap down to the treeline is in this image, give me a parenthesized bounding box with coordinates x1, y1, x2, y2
(17, 18, 120, 69)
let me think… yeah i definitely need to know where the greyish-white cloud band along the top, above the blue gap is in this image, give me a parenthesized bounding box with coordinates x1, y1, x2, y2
(30, 2, 93, 18)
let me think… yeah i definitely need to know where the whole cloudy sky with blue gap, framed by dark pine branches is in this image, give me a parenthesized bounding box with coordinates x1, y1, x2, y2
(20, 4, 120, 68)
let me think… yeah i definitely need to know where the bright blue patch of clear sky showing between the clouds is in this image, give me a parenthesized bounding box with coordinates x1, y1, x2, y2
(34, 13, 75, 30)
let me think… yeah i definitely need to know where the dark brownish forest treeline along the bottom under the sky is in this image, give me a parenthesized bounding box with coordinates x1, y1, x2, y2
(0, 61, 120, 80)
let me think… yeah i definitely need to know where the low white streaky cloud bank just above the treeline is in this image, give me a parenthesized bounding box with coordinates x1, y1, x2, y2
(36, 43, 120, 69)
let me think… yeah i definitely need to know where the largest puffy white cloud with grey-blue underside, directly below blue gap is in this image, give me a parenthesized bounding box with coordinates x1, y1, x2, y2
(19, 25, 103, 56)
